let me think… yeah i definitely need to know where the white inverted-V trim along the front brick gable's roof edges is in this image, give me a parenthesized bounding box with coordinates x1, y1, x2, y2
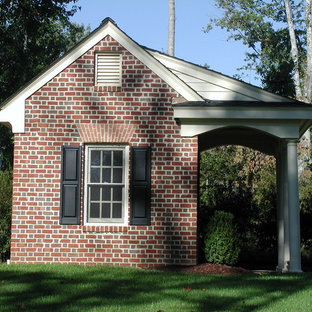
(0, 18, 203, 132)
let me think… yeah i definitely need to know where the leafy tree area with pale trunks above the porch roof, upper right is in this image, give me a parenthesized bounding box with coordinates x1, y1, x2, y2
(207, 0, 312, 103)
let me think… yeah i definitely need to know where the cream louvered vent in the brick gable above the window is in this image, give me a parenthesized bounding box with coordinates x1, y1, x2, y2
(96, 53, 121, 86)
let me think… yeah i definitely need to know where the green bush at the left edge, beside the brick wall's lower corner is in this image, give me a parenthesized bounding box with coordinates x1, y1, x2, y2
(0, 170, 12, 261)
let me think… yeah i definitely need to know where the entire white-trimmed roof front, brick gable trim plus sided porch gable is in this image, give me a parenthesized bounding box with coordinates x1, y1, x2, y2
(0, 18, 296, 132)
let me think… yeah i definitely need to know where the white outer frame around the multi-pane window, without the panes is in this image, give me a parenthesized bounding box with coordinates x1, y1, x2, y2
(83, 144, 129, 226)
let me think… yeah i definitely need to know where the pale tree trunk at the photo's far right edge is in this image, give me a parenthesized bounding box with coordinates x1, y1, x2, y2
(304, 0, 312, 104)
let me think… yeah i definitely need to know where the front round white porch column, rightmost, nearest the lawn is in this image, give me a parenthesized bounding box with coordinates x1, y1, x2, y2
(286, 140, 302, 272)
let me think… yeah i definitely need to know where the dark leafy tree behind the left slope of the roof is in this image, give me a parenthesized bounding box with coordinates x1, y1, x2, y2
(0, 0, 89, 170)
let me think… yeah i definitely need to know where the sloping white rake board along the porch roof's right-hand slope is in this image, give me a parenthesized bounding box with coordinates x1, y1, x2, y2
(150, 51, 292, 102)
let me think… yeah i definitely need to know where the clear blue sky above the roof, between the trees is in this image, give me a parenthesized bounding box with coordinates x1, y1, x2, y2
(72, 0, 259, 84)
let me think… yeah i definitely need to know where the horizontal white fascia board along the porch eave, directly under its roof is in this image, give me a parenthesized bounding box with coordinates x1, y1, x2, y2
(174, 104, 312, 120)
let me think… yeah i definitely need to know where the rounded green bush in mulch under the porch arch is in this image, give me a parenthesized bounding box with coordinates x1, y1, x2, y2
(205, 211, 240, 265)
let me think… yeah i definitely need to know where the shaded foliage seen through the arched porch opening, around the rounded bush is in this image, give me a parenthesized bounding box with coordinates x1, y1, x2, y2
(198, 145, 277, 270)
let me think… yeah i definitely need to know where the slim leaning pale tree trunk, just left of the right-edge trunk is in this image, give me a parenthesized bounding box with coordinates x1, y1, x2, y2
(284, 0, 302, 100)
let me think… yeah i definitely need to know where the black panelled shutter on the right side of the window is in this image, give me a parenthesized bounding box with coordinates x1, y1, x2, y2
(130, 146, 151, 225)
